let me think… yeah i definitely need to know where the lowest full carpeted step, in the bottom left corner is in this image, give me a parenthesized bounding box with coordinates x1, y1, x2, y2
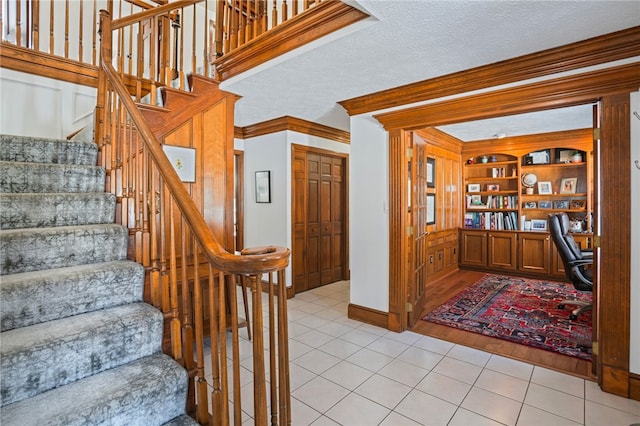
(0, 354, 187, 426)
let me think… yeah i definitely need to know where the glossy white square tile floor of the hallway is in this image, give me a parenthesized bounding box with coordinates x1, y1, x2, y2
(205, 281, 640, 426)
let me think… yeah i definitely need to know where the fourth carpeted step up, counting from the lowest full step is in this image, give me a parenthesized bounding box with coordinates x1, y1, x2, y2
(0, 224, 128, 275)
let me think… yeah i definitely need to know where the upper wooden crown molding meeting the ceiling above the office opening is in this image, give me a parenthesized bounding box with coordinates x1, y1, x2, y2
(338, 26, 640, 115)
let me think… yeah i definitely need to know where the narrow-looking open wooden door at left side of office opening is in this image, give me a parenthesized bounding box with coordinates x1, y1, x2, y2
(407, 133, 427, 327)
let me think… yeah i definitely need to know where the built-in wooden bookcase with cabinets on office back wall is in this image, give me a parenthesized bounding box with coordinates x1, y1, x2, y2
(459, 129, 593, 278)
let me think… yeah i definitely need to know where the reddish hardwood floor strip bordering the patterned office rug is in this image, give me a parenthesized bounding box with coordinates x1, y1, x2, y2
(411, 270, 596, 381)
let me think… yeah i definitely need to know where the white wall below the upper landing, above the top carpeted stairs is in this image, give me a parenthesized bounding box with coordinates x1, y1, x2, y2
(0, 68, 97, 138)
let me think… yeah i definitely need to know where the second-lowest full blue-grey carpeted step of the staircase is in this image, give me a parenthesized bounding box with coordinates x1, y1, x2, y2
(0, 303, 163, 404)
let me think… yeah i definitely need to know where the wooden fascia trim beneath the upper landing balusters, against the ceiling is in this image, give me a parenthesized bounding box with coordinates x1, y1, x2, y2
(215, 1, 369, 80)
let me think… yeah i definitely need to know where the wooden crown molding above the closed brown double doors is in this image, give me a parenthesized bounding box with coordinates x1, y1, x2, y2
(236, 116, 351, 144)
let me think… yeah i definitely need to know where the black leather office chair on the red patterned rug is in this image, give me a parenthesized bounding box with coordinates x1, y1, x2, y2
(549, 213, 593, 320)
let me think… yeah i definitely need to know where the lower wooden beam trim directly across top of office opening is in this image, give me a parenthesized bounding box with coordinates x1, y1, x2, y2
(374, 62, 640, 130)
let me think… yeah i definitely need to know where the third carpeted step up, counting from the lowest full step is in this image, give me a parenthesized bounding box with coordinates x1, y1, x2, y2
(0, 260, 144, 331)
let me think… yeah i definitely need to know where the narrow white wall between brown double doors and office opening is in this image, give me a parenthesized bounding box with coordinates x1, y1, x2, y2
(349, 116, 389, 312)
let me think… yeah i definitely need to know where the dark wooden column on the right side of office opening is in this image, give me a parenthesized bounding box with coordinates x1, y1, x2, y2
(597, 93, 631, 397)
